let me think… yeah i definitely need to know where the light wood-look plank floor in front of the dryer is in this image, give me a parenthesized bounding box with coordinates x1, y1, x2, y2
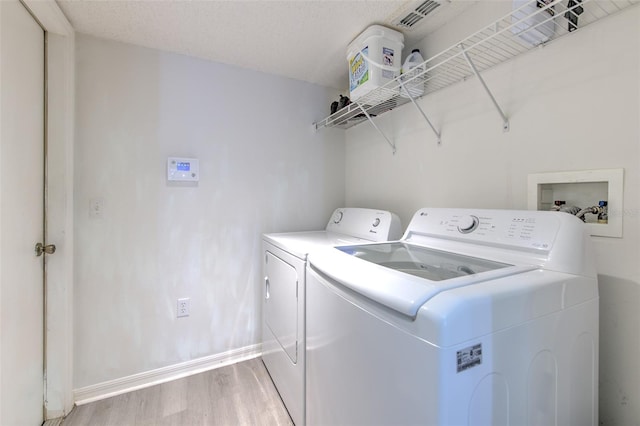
(62, 358, 293, 426)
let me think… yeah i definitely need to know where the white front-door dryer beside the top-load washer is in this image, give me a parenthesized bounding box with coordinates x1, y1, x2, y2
(262, 208, 402, 426)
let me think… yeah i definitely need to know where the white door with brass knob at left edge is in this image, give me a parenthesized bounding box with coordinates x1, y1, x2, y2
(0, 0, 44, 426)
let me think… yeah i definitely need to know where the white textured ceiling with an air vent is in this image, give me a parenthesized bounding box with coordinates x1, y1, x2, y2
(57, 0, 474, 90)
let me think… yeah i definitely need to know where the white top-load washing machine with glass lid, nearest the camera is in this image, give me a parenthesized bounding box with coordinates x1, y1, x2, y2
(306, 208, 599, 426)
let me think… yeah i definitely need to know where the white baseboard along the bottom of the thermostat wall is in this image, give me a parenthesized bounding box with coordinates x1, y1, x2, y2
(73, 344, 262, 405)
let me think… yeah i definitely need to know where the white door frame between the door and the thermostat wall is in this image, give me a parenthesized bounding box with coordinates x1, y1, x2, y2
(21, 0, 75, 420)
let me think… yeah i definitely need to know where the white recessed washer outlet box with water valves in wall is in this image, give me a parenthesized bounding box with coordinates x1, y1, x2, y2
(527, 169, 624, 238)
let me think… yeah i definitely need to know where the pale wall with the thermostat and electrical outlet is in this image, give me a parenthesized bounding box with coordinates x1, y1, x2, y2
(74, 35, 344, 389)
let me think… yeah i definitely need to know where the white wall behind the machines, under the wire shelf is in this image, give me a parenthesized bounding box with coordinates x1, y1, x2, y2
(346, 2, 640, 425)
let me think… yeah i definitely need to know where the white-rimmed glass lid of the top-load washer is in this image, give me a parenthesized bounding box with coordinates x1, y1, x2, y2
(309, 242, 537, 317)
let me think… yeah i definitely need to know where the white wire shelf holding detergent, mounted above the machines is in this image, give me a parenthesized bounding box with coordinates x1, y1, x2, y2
(314, 0, 640, 131)
